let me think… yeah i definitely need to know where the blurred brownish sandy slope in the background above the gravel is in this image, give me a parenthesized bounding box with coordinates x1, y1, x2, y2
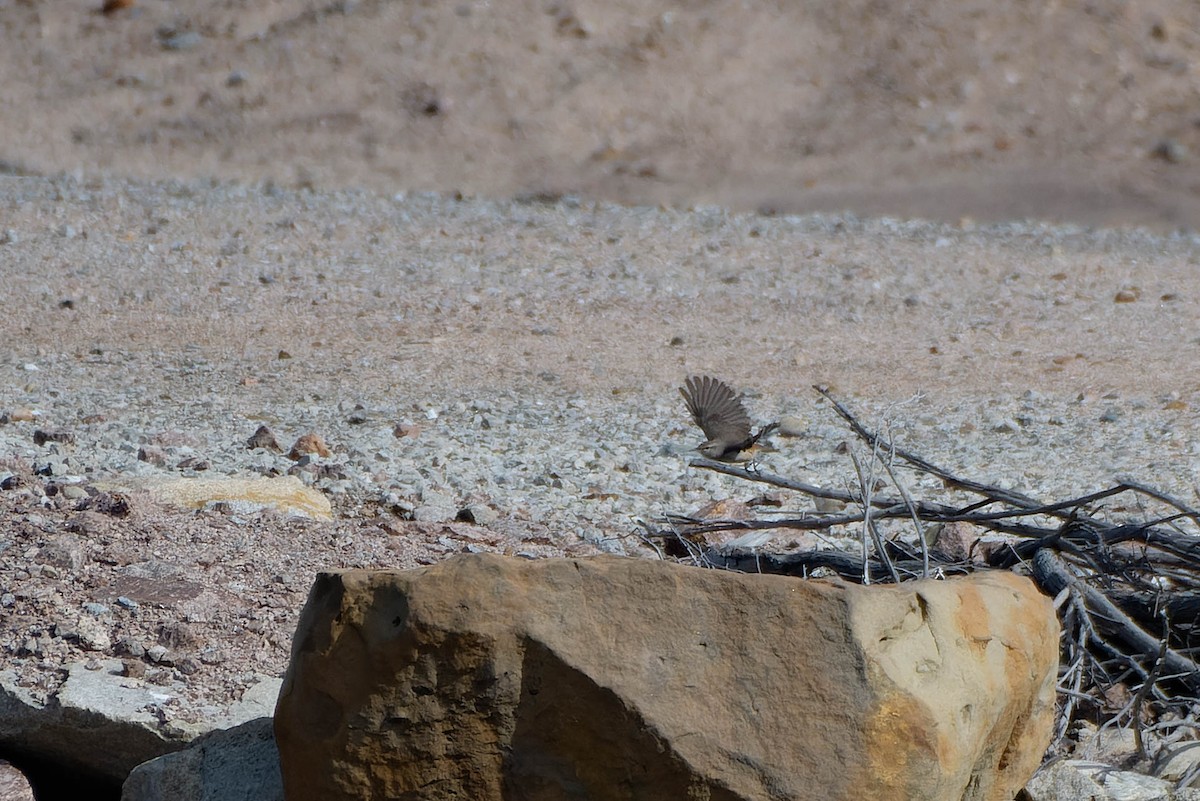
(7, 0, 1200, 228)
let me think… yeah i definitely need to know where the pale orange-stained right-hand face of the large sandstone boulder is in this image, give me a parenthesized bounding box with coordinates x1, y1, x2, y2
(852, 572, 1058, 801)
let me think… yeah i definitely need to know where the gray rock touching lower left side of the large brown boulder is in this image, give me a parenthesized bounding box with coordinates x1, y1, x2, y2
(121, 717, 283, 801)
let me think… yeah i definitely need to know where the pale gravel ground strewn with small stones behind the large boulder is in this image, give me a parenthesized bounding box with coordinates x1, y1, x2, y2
(0, 173, 1200, 721)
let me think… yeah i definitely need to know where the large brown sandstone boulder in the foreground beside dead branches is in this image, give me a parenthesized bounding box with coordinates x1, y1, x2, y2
(275, 555, 1058, 801)
